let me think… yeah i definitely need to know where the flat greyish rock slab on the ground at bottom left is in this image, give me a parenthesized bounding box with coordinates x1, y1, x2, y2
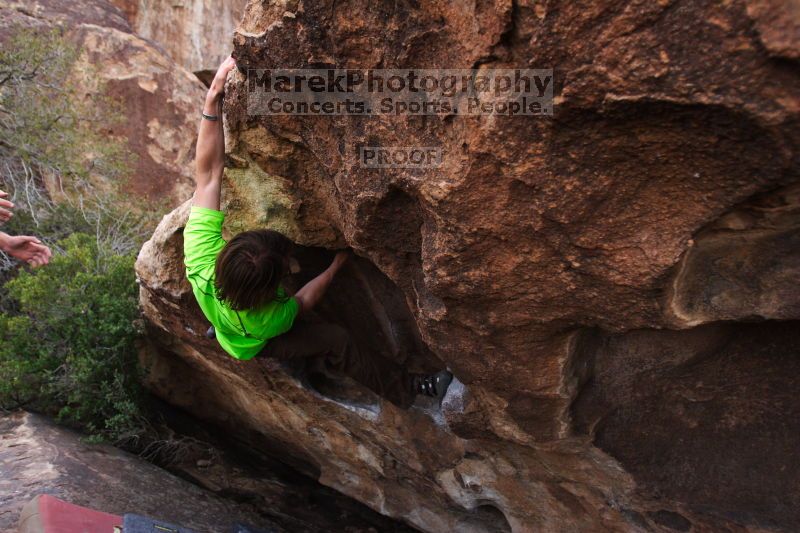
(0, 412, 412, 533)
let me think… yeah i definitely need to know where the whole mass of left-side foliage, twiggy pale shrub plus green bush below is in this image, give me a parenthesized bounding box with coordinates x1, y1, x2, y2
(0, 28, 154, 441)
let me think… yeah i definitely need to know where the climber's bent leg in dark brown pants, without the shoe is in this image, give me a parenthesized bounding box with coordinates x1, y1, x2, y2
(260, 321, 414, 407)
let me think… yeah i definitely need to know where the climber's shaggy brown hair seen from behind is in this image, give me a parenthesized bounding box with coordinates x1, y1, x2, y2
(214, 230, 292, 311)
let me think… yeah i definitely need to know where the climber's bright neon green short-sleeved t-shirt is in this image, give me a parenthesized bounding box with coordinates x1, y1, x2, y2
(183, 206, 299, 359)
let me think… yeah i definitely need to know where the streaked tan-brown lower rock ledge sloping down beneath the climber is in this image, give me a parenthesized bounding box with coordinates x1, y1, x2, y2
(138, 204, 644, 532)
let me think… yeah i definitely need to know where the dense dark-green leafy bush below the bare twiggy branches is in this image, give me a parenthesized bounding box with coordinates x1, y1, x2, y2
(0, 233, 143, 440)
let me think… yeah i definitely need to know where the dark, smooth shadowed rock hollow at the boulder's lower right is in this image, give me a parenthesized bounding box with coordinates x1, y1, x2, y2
(574, 322, 800, 531)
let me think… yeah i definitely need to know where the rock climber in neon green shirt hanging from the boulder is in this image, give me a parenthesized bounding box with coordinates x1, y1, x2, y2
(183, 57, 452, 408)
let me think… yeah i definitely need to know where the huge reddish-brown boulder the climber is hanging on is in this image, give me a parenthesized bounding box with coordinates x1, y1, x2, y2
(137, 0, 800, 532)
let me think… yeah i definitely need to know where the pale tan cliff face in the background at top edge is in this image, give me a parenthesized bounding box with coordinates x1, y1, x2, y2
(111, 0, 247, 74)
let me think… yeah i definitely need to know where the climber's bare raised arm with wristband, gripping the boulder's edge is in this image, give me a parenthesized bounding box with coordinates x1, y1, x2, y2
(192, 57, 236, 210)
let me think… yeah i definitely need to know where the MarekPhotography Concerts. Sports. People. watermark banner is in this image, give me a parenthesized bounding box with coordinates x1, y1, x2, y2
(247, 68, 553, 116)
